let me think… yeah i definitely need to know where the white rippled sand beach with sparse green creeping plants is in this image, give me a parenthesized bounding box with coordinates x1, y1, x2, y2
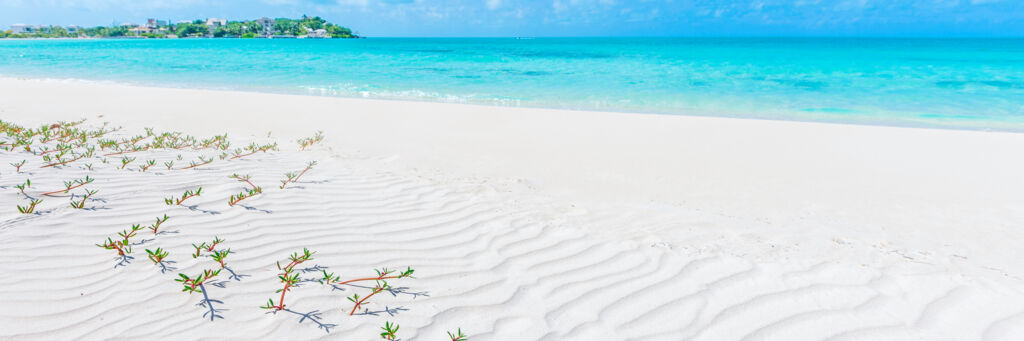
(0, 78, 1024, 340)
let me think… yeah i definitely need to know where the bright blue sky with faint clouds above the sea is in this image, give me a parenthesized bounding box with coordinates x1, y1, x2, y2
(0, 0, 1024, 37)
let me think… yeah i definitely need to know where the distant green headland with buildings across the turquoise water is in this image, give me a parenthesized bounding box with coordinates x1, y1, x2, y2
(0, 15, 359, 38)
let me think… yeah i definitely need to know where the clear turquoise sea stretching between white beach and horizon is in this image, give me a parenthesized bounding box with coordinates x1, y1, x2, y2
(0, 38, 1024, 131)
